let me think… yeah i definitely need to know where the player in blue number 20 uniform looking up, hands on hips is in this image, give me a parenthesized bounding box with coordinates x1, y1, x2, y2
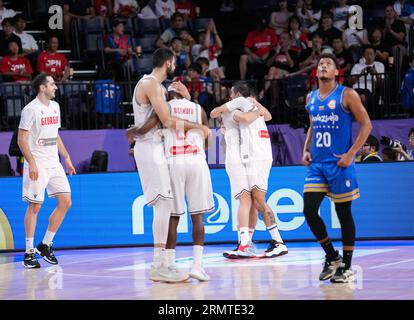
(302, 53, 372, 282)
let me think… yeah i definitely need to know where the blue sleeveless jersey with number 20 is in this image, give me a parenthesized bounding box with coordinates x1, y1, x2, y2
(306, 84, 353, 162)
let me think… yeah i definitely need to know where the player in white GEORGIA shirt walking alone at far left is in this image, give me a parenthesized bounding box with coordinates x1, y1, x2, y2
(18, 73, 76, 269)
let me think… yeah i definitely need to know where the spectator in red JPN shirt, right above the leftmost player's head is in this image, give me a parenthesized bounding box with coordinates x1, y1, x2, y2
(37, 36, 70, 81)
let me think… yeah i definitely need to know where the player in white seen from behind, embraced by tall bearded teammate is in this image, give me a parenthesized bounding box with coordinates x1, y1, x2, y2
(164, 86, 214, 281)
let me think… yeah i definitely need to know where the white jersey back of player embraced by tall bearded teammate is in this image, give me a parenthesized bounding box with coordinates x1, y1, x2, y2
(164, 99, 205, 159)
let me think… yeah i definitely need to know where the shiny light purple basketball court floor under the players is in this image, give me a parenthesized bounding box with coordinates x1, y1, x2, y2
(0, 241, 414, 300)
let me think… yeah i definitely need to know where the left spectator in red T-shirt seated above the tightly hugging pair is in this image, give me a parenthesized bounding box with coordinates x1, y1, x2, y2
(239, 19, 278, 80)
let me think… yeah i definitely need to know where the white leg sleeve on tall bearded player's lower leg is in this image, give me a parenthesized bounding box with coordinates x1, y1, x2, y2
(152, 200, 171, 245)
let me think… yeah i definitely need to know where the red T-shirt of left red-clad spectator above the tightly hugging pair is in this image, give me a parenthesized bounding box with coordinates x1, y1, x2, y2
(244, 28, 278, 57)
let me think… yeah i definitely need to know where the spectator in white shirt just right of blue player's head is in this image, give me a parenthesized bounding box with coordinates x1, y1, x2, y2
(350, 45, 384, 107)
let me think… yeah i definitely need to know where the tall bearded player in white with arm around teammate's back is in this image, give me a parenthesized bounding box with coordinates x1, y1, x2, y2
(127, 48, 210, 282)
